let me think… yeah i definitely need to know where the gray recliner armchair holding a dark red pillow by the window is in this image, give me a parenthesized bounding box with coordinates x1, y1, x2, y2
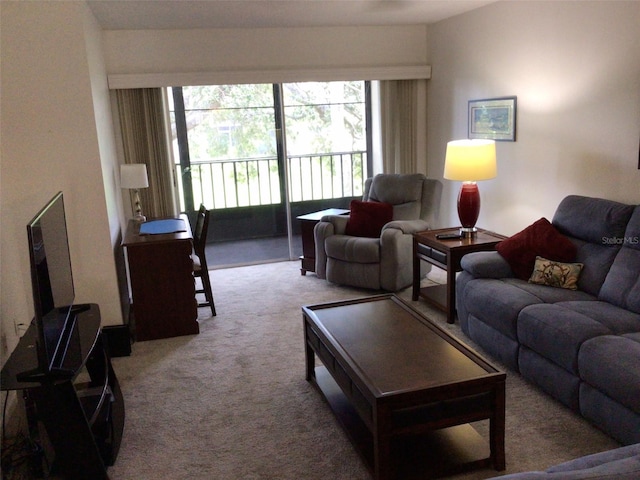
(314, 174, 442, 292)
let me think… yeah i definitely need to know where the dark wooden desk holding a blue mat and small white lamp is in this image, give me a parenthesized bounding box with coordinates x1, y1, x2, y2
(122, 215, 200, 341)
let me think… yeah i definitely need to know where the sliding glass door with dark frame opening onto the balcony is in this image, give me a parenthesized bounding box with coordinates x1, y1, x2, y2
(169, 82, 370, 266)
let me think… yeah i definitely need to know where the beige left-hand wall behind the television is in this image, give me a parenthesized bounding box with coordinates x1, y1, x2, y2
(0, 1, 122, 363)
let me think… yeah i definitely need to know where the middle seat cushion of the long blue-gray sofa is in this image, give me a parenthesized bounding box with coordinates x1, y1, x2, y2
(517, 304, 612, 375)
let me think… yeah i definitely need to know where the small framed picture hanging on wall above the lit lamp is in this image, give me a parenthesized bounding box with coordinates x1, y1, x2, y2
(468, 96, 517, 142)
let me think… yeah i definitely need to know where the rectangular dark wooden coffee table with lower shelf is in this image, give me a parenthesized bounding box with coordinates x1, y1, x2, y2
(302, 295, 506, 480)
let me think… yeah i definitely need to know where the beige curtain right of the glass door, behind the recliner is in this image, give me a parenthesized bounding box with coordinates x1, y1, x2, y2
(380, 80, 427, 174)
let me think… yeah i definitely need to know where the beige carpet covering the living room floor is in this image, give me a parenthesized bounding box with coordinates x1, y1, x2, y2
(109, 262, 617, 480)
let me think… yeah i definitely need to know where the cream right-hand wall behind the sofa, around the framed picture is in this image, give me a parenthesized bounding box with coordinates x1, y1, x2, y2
(427, 1, 640, 234)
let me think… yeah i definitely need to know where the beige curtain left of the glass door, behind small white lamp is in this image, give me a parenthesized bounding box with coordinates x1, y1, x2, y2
(116, 88, 177, 218)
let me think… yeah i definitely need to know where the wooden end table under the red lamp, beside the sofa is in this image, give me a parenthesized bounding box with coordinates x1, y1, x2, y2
(412, 228, 507, 323)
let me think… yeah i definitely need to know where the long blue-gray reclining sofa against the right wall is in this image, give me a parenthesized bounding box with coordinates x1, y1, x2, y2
(456, 195, 640, 444)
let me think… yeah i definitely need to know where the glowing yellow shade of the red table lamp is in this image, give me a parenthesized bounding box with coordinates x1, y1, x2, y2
(444, 139, 497, 182)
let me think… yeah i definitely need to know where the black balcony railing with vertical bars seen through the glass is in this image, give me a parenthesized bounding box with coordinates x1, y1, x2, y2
(175, 151, 367, 211)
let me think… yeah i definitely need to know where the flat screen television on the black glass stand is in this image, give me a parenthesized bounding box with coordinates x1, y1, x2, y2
(19, 192, 75, 380)
